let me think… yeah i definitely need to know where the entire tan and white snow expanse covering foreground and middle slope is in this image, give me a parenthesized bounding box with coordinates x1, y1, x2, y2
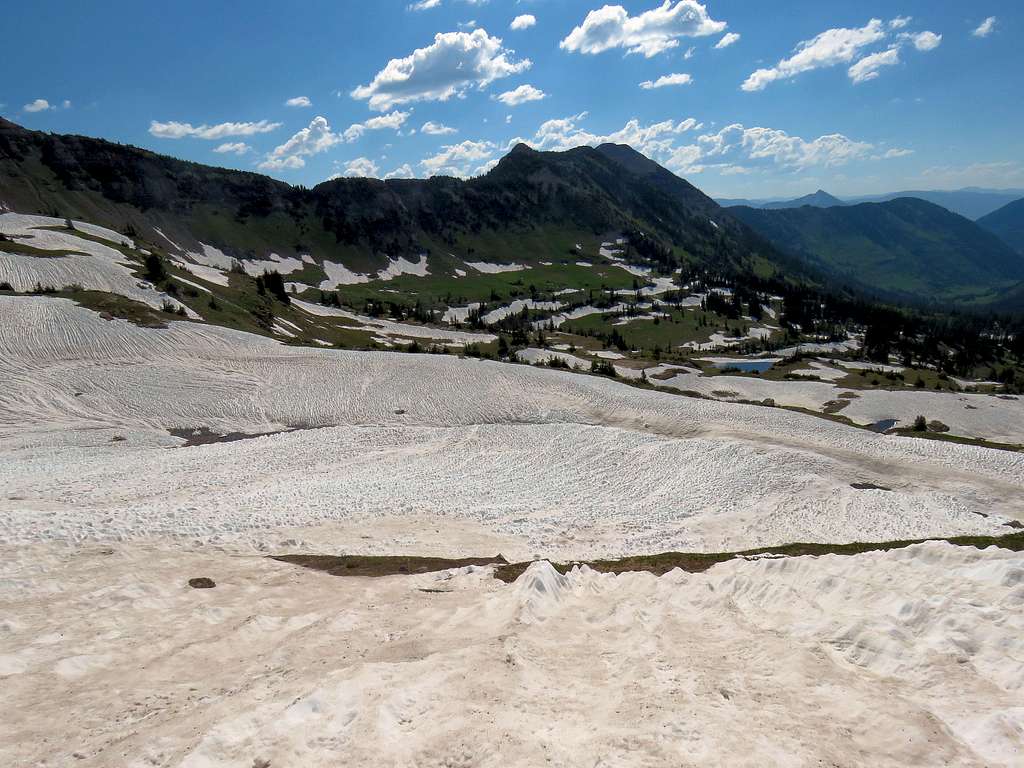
(0, 297, 1024, 768)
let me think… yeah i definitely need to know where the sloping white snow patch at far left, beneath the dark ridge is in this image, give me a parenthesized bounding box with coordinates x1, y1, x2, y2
(0, 213, 199, 318)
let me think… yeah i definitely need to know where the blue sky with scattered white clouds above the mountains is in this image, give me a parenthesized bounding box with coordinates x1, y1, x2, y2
(0, 0, 1024, 197)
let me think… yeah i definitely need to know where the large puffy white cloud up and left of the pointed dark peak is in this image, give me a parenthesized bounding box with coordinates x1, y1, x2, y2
(351, 29, 532, 112)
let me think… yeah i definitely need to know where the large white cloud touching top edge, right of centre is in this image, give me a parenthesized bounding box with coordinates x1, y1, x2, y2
(560, 0, 727, 58)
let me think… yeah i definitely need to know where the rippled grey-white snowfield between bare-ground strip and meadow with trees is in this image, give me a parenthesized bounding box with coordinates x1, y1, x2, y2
(0, 297, 1024, 557)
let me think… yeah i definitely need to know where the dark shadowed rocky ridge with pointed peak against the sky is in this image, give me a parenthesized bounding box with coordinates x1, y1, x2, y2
(0, 121, 793, 281)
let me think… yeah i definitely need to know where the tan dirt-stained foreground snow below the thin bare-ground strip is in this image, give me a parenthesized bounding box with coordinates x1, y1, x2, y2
(0, 544, 1024, 768)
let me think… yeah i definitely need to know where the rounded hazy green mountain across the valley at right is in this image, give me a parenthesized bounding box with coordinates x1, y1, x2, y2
(728, 198, 1024, 304)
